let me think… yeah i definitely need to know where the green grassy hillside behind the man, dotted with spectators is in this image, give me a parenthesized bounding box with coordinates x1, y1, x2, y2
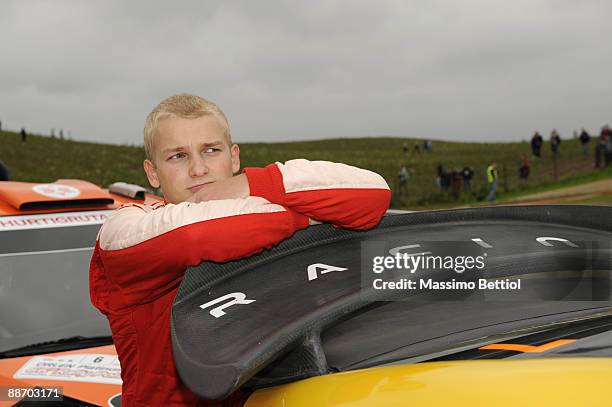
(0, 132, 612, 209)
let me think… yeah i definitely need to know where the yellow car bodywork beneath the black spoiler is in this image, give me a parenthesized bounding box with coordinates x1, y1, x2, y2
(245, 358, 612, 407)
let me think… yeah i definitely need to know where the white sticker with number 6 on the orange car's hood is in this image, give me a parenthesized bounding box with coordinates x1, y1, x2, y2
(13, 353, 122, 384)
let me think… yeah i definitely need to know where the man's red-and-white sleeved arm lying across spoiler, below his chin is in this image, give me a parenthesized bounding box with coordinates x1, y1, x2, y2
(96, 197, 308, 304)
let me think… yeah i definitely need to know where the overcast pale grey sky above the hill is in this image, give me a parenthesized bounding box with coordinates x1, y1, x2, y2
(0, 0, 612, 144)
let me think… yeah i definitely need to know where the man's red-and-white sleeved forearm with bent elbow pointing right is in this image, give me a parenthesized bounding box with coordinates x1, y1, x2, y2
(244, 159, 391, 229)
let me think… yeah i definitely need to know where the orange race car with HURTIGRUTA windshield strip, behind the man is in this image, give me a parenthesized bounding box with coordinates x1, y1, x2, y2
(0, 180, 160, 406)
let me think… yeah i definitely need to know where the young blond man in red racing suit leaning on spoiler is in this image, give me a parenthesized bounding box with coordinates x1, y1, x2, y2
(90, 94, 390, 407)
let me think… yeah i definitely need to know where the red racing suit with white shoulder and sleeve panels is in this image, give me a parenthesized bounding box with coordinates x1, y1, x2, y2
(89, 160, 391, 407)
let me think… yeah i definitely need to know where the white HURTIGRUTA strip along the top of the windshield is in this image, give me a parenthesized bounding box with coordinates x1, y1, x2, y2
(0, 211, 112, 231)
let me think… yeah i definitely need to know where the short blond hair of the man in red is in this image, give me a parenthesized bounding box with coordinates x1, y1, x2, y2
(144, 93, 232, 160)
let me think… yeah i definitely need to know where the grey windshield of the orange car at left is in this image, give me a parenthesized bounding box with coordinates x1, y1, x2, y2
(0, 225, 110, 352)
